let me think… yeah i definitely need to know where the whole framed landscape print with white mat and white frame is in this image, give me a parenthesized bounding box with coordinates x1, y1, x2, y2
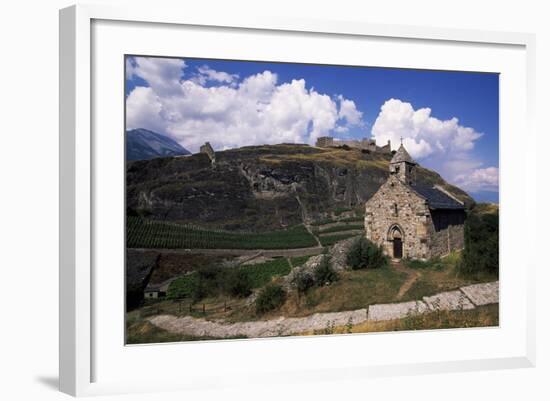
(60, 6, 536, 395)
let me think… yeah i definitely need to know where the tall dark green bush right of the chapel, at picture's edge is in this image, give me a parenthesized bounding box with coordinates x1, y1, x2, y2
(458, 205, 498, 274)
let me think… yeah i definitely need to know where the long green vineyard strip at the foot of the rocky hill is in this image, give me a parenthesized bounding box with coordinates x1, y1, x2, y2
(126, 216, 317, 249)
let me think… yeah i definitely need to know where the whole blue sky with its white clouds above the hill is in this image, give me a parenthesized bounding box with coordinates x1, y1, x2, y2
(126, 57, 499, 202)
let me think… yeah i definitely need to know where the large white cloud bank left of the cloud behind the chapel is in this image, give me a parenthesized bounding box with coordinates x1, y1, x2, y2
(126, 57, 362, 151)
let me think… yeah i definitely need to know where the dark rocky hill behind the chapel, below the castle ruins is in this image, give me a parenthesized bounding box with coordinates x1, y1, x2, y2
(126, 144, 473, 230)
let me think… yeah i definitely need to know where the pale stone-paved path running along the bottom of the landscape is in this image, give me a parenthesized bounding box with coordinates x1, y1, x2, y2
(148, 281, 499, 338)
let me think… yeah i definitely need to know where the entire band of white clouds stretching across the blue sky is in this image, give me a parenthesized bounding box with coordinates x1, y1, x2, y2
(126, 57, 498, 192)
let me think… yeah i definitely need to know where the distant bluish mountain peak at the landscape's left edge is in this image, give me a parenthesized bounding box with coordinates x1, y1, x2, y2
(126, 128, 191, 160)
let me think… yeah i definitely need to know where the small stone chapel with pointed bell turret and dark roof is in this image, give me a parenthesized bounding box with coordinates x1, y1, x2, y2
(365, 144, 466, 260)
